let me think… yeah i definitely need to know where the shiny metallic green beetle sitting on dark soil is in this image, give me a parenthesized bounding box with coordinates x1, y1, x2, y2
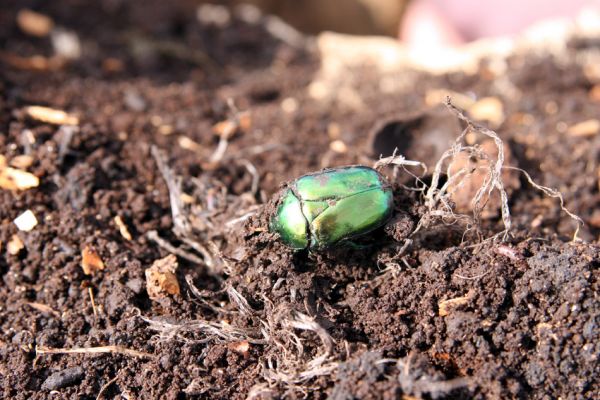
(270, 166, 394, 250)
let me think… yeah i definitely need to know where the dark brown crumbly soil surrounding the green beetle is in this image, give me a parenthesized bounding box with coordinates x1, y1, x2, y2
(0, 0, 600, 399)
